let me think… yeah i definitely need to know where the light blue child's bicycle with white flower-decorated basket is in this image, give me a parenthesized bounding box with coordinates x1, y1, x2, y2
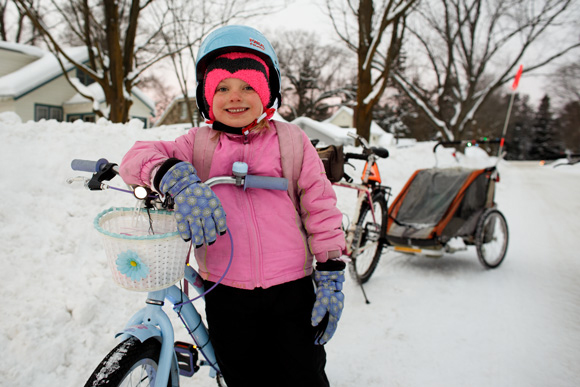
(69, 159, 288, 387)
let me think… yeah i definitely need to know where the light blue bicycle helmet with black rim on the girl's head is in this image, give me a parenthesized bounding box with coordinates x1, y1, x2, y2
(195, 25, 282, 119)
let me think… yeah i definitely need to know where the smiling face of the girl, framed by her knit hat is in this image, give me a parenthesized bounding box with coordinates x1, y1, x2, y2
(212, 78, 263, 128)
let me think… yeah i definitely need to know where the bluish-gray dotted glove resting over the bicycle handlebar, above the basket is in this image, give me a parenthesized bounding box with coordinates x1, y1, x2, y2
(159, 162, 227, 247)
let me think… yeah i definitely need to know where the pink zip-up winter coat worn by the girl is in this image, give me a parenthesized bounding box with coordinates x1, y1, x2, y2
(120, 124, 345, 289)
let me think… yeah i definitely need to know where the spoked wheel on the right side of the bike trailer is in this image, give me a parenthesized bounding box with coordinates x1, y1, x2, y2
(475, 209, 509, 269)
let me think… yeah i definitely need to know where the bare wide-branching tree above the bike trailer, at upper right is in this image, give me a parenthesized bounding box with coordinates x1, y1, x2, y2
(394, 0, 580, 139)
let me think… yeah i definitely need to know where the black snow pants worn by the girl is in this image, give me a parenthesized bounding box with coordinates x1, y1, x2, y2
(205, 277, 329, 387)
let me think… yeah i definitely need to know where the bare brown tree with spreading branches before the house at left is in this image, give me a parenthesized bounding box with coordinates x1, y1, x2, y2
(14, 0, 284, 122)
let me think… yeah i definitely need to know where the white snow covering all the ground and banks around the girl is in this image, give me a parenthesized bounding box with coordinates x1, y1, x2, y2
(0, 113, 580, 387)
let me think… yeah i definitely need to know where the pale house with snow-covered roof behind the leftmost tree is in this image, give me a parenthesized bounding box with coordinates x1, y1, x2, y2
(0, 41, 155, 128)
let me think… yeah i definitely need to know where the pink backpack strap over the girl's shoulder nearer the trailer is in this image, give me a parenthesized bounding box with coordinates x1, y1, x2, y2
(271, 120, 304, 213)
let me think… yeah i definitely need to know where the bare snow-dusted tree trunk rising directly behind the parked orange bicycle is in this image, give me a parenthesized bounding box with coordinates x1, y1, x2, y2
(326, 0, 418, 140)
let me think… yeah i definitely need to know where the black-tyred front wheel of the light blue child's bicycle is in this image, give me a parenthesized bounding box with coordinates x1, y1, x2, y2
(85, 337, 172, 387)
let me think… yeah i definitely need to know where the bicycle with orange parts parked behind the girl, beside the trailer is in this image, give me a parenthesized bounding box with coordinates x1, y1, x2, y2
(322, 133, 391, 303)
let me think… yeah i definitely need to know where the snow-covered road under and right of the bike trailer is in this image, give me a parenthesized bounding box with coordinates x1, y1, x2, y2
(329, 162, 580, 387)
